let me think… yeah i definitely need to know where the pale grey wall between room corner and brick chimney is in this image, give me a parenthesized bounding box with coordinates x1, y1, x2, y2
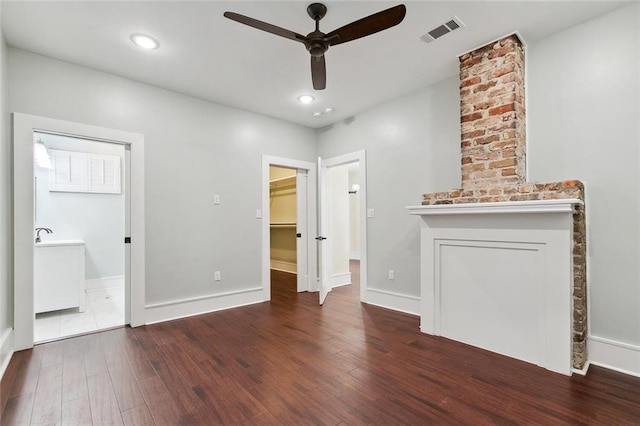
(318, 77, 460, 302)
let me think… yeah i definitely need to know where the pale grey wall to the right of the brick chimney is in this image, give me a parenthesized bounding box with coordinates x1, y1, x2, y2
(527, 3, 640, 352)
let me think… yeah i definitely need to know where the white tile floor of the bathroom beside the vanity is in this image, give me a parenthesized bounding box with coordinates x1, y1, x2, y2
(33, 286, 124, 343)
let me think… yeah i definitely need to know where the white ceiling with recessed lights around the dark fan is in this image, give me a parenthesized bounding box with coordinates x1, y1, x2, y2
(2, 0, 628, 128)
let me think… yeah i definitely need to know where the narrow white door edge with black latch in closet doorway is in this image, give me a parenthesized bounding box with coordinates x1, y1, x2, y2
(296, 169, 309, 292)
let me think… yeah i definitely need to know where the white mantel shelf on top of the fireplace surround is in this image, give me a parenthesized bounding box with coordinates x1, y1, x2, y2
(406, 198, 584, 216)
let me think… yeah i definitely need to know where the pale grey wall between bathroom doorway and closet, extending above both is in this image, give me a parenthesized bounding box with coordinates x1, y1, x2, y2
(9, 48, 316, 308)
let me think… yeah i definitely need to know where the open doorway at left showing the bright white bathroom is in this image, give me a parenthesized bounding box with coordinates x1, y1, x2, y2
(34, 131, 126, 343)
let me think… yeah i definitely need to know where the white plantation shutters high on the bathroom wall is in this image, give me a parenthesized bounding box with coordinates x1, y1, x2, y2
(49, 149, 121, 194)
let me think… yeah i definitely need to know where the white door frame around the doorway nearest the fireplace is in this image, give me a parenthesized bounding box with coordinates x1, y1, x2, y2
(318, 150, 368, 302)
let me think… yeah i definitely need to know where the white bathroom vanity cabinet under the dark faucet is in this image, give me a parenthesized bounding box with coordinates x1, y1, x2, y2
(33, 240, 85, 313)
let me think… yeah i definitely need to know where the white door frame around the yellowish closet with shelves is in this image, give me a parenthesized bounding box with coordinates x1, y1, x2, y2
(261, 155, 318, 301)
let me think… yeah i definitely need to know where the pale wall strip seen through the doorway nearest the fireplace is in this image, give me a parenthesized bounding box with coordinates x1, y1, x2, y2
(327, 165, 350, 282)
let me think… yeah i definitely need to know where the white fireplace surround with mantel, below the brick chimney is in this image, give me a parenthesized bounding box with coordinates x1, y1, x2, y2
(408, 199, 582, 375)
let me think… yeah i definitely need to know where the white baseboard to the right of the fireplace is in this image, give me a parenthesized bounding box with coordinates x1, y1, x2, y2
(587, 335, 640, 377)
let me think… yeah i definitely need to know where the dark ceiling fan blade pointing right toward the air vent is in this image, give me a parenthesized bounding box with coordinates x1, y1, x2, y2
(324, 4, 407, 46)
